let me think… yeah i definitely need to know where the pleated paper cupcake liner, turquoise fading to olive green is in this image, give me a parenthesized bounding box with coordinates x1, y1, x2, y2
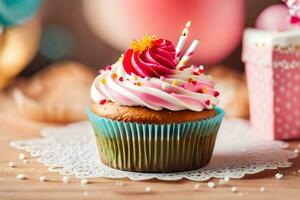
(86, 108, 224, 172)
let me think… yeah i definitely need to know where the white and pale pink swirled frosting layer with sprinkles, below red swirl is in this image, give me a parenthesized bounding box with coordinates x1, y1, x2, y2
(91, 62, 219, 111)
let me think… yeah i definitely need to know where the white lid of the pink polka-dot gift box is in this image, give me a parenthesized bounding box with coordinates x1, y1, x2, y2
(242, 28, 300, 64)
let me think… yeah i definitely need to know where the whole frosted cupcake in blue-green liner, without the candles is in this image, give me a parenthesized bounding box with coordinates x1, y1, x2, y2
(87, 35, 224, 172)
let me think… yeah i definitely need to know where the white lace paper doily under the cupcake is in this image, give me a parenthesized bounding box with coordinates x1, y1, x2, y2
(10, 119, 297, 181)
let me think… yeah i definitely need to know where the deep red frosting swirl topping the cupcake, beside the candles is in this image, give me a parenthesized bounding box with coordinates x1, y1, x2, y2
(123, 39, 178, 77)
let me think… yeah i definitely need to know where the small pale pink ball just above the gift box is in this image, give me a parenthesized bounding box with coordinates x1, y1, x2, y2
(255, 4, 293, 30)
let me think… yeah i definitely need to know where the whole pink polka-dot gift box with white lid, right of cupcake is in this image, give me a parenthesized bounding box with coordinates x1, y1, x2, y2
(242, 29, 300, 140)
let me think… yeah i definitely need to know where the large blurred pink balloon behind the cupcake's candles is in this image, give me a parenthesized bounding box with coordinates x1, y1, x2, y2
(84, 0, 245, 64)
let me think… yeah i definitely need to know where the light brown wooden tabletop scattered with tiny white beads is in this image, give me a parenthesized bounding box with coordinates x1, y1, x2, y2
(0, 94, 300, 200)
